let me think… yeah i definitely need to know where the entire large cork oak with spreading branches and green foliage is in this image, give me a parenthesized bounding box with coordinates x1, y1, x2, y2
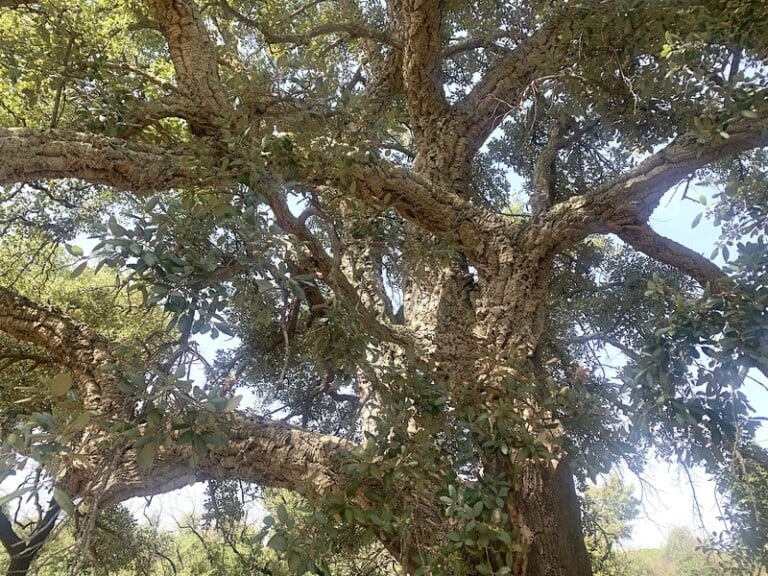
(0, 0, 768, 576)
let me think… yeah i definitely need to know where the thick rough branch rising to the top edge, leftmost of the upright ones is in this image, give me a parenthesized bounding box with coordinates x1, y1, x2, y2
(147, 0, 229, 131)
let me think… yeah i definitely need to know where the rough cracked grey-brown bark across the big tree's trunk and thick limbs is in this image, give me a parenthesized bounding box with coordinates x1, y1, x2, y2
(0, 0, 768, 576)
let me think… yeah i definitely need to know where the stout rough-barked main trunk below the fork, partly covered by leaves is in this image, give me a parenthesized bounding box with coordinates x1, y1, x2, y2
(396, 264, 592, 576)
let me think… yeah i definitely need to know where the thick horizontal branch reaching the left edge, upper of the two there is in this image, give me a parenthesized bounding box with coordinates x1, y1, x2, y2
(0, 128, 198, 193)
